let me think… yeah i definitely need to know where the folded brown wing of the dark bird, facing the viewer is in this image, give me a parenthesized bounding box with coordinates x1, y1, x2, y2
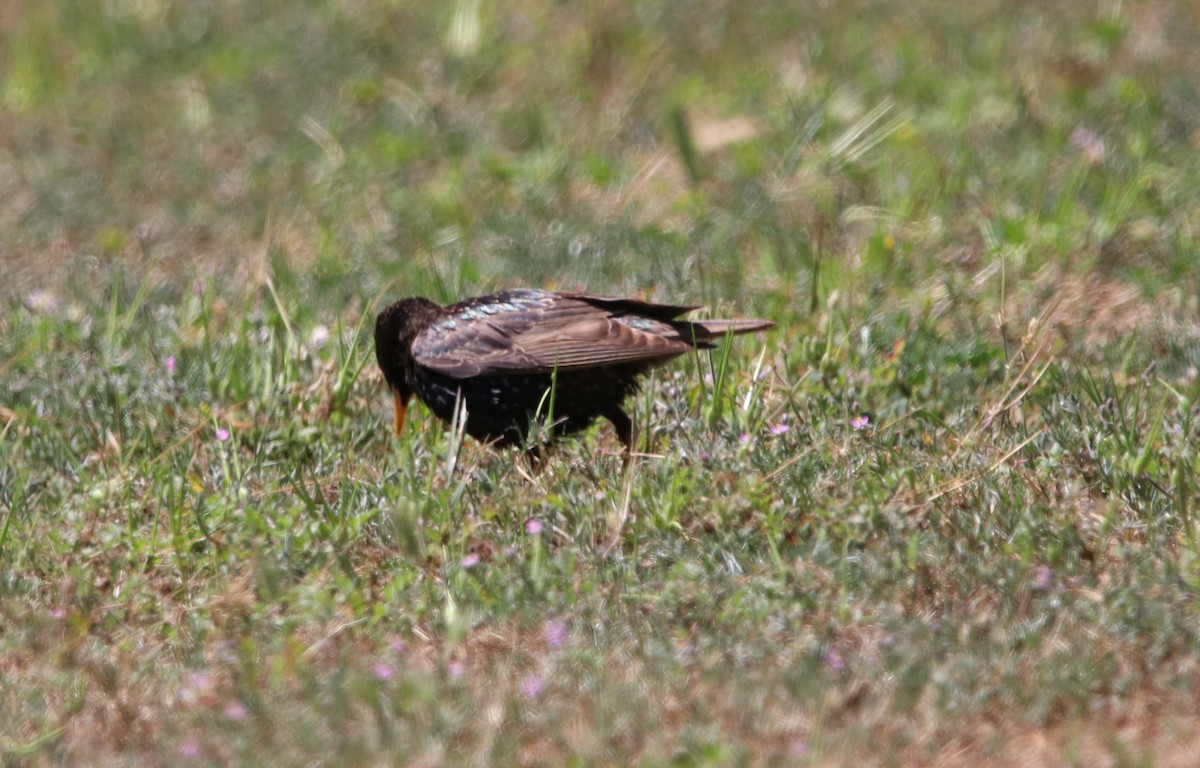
(413, 292, 692, 378)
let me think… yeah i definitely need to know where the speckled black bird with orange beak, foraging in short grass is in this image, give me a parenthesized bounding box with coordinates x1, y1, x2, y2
(376, 289, 774, 452)
